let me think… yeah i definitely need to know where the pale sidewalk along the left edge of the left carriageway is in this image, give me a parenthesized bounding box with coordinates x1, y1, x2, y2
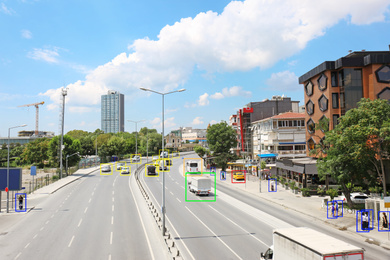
(0, 166, 100, 217)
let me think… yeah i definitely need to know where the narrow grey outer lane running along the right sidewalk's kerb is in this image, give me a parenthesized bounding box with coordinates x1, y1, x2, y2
(217, 179, 388, 259)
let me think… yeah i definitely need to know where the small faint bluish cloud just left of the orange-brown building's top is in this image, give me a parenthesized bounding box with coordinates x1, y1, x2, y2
(267, 70, 302, 91)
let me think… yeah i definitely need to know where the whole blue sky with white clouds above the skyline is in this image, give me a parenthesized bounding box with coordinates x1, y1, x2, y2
(0, 0, 390, 137)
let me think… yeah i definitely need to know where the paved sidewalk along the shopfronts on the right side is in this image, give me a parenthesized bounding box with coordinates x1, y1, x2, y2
(212, 169, 390, 249)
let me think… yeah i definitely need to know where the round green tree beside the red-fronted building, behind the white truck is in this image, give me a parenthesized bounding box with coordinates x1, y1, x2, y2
(206, 121, 237, 171)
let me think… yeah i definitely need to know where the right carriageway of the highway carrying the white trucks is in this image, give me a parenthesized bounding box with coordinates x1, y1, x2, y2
(142, 152, 389, 259)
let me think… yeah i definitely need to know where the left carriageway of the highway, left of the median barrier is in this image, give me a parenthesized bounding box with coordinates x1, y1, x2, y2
(0, 162, 170, 260)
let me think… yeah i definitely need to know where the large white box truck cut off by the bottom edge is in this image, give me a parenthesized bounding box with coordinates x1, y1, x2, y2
(260, 227, 365, 260)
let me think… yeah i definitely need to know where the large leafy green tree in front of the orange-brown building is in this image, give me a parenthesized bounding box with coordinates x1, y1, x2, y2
(317, 99, 390, 207)
